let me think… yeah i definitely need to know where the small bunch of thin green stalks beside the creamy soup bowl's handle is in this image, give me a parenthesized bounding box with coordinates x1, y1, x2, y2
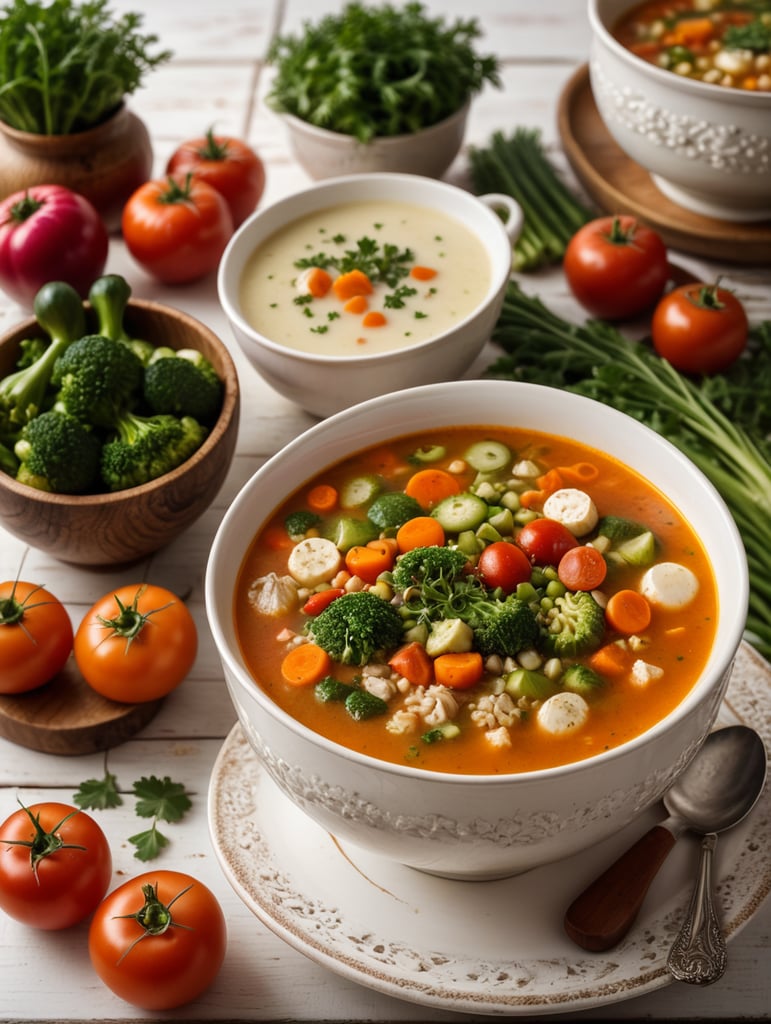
(469, 128, 596, 271)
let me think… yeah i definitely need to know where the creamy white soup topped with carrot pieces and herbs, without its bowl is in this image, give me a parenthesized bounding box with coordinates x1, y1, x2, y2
(240, 202, 490, 356)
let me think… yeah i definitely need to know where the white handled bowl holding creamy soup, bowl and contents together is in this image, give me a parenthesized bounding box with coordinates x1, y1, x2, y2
(213, 173, 522, 417)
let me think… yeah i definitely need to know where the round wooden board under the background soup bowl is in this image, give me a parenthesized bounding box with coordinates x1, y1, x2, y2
(557, 65, 771, 265)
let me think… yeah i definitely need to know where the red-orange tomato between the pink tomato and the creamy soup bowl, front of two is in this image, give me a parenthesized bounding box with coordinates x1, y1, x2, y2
(121, 175, 233, 285)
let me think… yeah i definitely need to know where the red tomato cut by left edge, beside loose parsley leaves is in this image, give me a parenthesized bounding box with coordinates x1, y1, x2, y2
(0, 803, 113, 931)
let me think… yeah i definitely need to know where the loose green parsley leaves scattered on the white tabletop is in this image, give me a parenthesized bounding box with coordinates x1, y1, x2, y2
(73, 768, 192, 860)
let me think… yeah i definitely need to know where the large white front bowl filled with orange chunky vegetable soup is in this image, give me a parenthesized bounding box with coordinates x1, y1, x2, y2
(206, 380, 748, 880)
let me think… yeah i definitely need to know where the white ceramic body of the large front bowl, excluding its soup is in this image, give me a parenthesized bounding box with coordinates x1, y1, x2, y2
(206, 381, 748, 879)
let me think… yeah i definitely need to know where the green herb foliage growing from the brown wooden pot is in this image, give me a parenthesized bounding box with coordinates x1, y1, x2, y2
(0, 0, 171, 135)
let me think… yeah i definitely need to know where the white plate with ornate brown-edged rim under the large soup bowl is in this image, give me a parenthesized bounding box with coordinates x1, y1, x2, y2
(209, 644, 771, 1017)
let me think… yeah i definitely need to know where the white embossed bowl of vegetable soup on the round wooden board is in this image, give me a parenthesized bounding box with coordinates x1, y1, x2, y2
(589, 0, 771, 221)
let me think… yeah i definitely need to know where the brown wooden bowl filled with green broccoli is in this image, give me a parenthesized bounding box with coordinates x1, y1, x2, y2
(0, 274, 240, 565)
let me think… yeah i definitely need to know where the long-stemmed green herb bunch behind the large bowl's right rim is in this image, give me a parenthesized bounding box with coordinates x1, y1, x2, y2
(487, 281, 771, 657)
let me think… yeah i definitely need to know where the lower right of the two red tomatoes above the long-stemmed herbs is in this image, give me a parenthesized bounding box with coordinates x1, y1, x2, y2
(651, 284, 749, 374)
